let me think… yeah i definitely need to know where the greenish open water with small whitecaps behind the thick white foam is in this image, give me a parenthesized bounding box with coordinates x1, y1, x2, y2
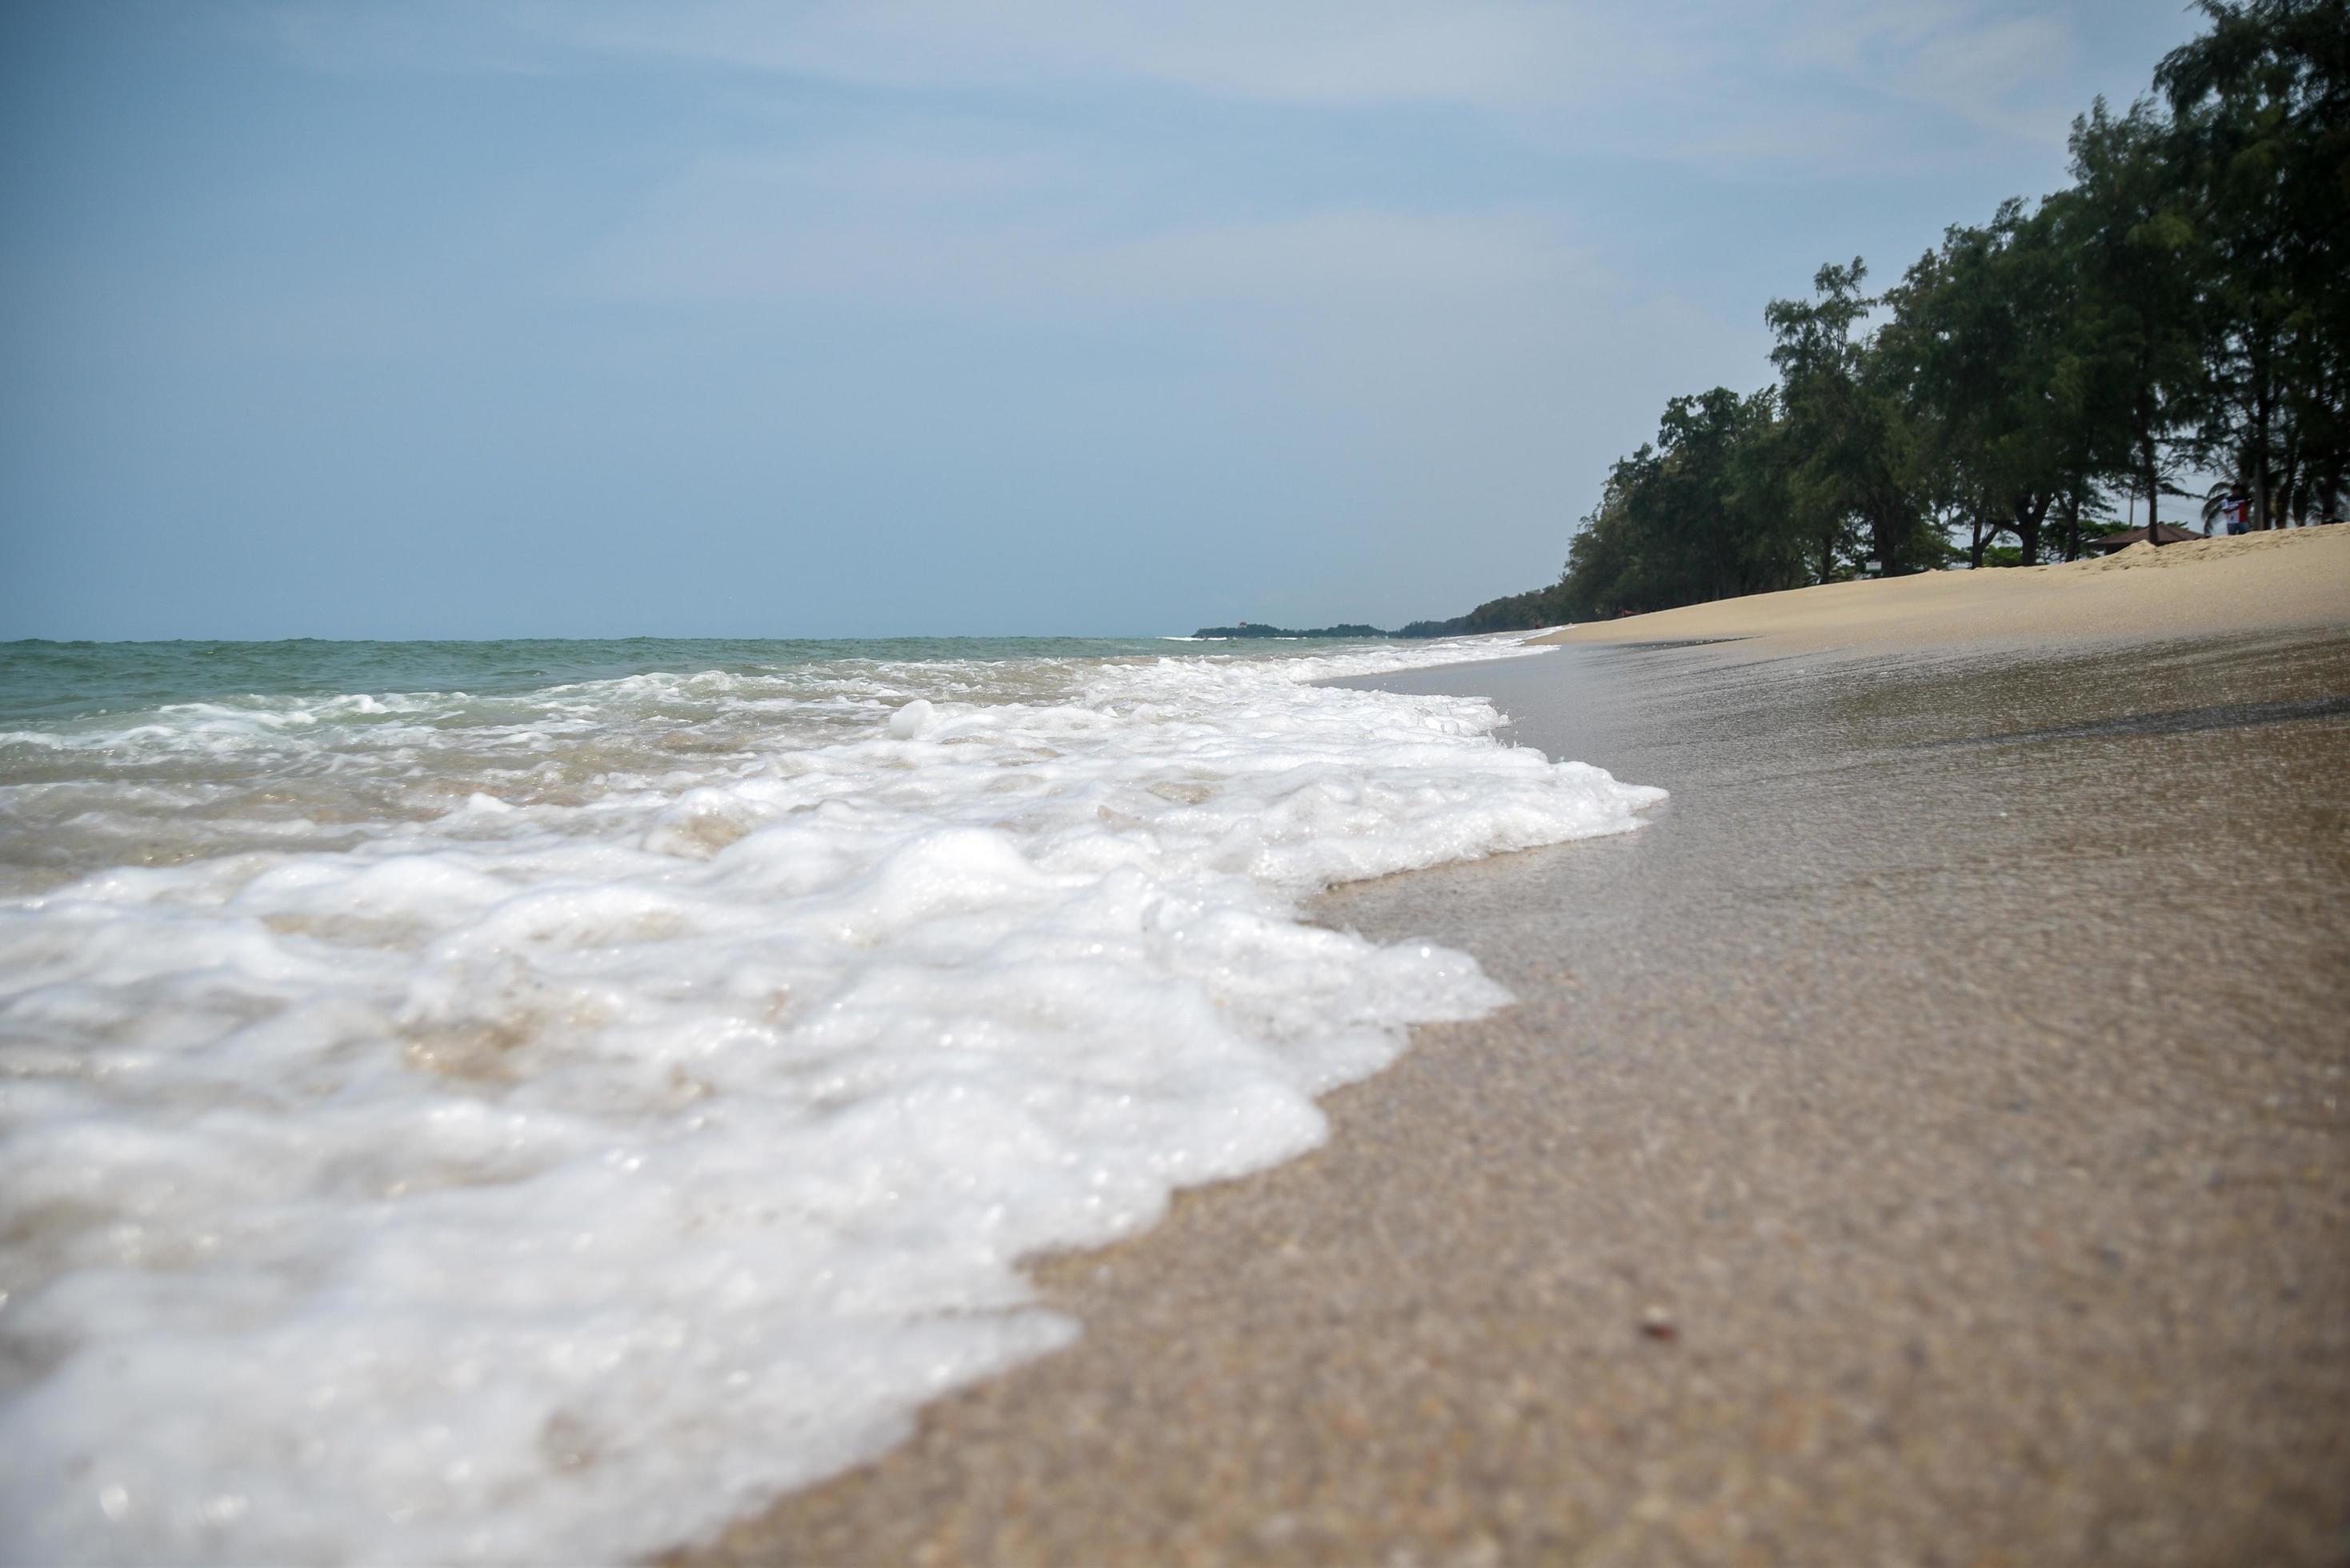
(0, 637, 1391, 898)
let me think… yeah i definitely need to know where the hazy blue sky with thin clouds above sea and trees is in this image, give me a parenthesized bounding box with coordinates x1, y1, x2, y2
(0, 0, 2197, 639)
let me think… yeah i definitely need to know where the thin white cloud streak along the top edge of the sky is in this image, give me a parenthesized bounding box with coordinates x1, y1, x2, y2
(278, 0, 2082, 186)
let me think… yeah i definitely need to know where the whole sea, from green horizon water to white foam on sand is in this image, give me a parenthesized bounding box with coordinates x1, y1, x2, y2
(0, 637, 1661, 1563)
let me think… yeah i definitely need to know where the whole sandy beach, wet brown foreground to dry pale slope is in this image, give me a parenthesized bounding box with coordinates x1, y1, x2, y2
(700, 529, 2350, 1563)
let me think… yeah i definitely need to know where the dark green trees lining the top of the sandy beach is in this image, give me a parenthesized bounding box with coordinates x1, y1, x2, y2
(1456, 0, 2350, 634)
